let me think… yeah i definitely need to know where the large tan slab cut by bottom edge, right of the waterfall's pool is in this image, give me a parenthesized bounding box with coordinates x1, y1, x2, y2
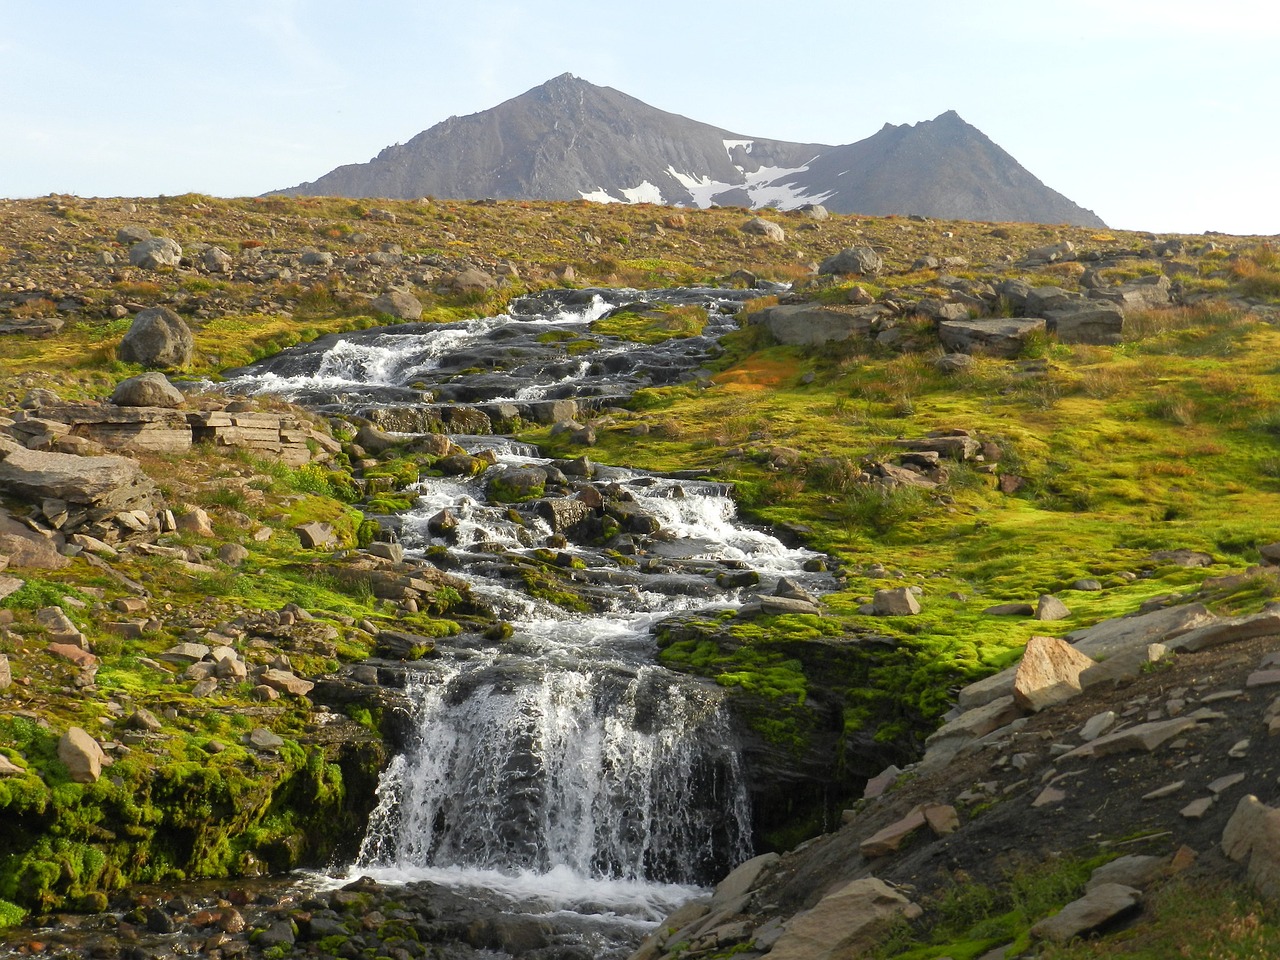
(769, 877, 922, 960)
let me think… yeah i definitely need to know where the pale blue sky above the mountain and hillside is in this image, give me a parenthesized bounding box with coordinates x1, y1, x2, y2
(0, 0, 1280, 234)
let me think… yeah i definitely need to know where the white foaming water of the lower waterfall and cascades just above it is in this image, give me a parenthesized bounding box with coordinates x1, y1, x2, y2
(357, 442, 829, 919)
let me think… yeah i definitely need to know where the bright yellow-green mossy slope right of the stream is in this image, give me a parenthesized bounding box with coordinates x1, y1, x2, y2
(529, 296, 1280, 754)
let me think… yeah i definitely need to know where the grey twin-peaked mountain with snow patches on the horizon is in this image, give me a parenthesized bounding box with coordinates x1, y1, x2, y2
(276, 73, 1105, 227)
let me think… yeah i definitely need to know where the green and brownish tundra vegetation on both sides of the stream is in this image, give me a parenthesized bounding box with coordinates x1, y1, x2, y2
(0, 195, 1280, 957)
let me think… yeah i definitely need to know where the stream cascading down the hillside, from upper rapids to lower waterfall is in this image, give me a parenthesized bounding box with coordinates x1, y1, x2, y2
(224, 291, 826, 956)
